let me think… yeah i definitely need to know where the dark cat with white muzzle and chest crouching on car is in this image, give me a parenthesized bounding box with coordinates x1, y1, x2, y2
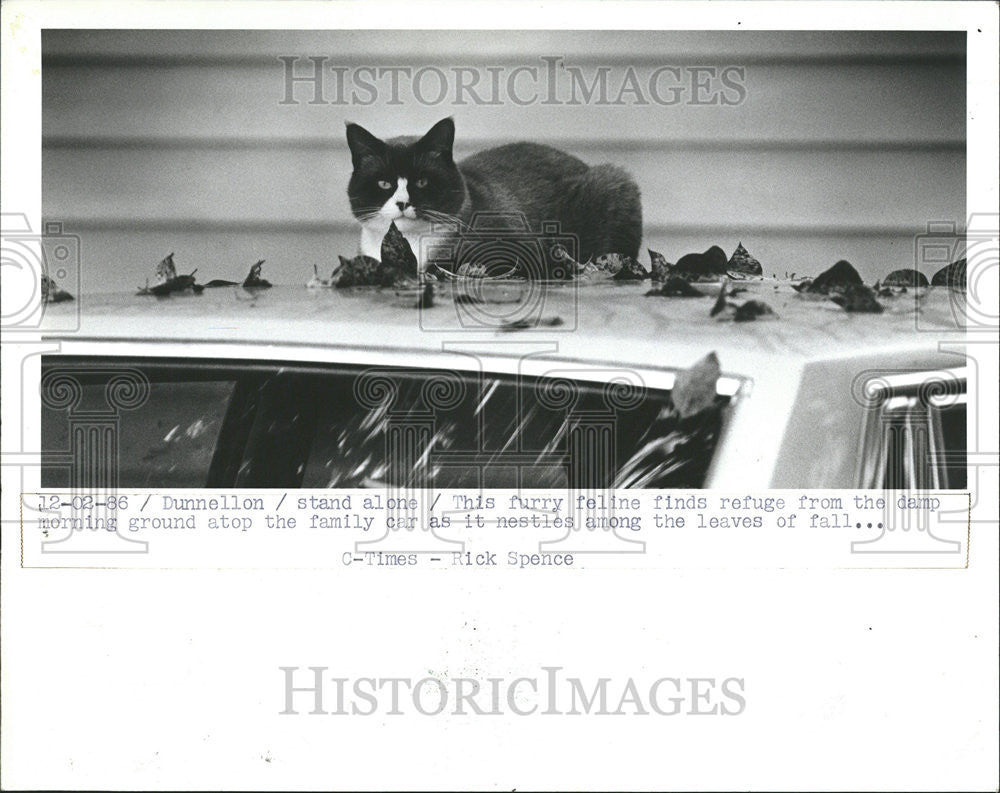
(347, 118, 642, 277)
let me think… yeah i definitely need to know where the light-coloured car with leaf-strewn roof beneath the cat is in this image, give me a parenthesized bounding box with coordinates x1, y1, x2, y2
(41, 278, 967, 492)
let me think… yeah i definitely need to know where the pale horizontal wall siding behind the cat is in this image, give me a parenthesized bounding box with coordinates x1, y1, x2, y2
(42, 31, 966, 291)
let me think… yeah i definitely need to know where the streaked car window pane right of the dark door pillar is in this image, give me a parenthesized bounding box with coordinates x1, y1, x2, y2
(296, 372, 688, 488)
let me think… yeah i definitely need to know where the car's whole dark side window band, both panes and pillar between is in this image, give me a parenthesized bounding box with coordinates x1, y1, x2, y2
(42, 357, 726, 488)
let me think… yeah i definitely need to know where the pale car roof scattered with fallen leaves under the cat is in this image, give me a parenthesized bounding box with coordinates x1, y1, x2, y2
(42, 280, 964, 376)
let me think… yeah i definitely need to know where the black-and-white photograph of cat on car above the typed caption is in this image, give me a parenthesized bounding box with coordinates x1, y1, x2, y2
(33, 30, 976, 489)
